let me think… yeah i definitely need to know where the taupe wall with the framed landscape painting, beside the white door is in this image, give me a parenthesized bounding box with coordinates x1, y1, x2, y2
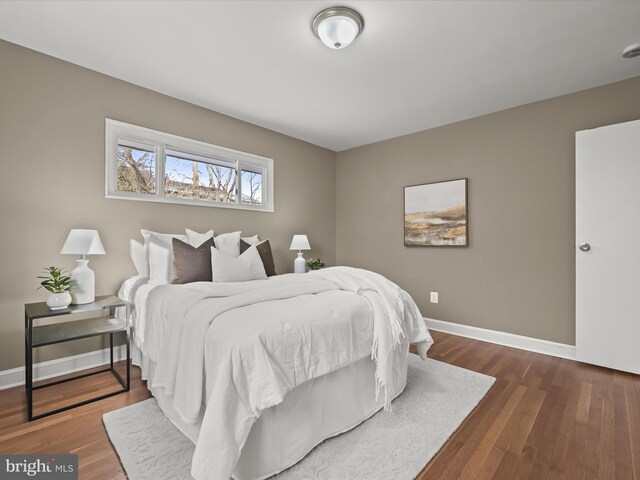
(336, 77, 640, 344)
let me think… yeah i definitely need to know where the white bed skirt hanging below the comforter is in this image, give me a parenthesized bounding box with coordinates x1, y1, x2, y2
(132, 345, 408, 480)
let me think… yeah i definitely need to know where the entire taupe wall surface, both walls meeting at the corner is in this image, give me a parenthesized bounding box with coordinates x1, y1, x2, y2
(0, 37, 640, 371)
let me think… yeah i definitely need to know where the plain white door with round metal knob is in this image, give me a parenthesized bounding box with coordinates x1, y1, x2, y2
(576, 120, 640, 373)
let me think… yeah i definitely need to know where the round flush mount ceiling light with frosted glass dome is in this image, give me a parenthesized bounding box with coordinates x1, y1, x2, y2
(311, 7, 364, 50)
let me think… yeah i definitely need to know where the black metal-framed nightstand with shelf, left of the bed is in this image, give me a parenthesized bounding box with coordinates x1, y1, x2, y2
(24, 295, 131, 421)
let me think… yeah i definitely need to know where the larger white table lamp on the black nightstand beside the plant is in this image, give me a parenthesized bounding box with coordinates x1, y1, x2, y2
(60, 228, 105, 305)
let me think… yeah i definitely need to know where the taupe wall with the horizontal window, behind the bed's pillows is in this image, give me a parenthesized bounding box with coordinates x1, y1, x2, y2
(0, 41, 336, 371)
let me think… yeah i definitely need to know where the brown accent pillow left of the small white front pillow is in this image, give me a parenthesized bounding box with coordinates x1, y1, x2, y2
(171, 238, 213, 283)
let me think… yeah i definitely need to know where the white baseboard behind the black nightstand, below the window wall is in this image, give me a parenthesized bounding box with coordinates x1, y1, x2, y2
(0, 345, 126, 390)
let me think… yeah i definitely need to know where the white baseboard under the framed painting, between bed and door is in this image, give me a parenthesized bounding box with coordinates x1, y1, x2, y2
(425, 318, 576, 360)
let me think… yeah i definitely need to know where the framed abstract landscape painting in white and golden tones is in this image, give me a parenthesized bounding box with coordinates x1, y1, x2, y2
(404, 178, 469, 247)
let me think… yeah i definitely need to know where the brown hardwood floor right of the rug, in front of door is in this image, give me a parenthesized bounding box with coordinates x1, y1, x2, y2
(418, 332, 640, 480)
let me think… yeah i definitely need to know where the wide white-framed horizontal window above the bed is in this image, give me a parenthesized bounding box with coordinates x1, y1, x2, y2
(106, 119, 273, 212)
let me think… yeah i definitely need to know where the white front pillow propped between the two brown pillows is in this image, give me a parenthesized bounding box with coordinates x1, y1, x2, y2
(211, 245, 267, 282)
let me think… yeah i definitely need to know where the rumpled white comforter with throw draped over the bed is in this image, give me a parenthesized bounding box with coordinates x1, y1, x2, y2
(136, 267, 432, 480)
